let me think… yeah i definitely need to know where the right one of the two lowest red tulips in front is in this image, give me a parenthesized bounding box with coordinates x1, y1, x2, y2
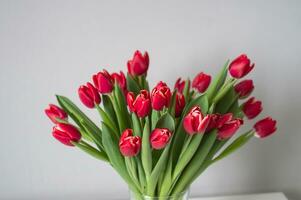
(150, 128, 172, 149)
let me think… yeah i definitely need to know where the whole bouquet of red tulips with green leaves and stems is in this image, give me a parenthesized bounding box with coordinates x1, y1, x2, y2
(45, 51, 276, 199)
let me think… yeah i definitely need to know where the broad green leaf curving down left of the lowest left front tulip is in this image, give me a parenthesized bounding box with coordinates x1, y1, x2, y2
(102, 123, 140, 193)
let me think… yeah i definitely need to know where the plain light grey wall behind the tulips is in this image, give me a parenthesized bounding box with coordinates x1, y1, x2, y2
(0, 0, 301, 200)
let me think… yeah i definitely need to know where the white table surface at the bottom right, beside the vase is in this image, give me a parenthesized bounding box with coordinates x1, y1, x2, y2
(191, 192, 287, 200)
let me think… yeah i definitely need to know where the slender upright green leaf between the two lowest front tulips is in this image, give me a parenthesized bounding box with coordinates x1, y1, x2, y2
(141, 118, 152, 180)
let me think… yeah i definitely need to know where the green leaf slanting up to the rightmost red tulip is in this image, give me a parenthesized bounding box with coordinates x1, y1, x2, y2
(212, 130, 254, 162)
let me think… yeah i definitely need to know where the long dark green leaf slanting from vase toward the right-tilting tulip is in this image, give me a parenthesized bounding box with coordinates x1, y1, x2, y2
(172, 130, 217, 194)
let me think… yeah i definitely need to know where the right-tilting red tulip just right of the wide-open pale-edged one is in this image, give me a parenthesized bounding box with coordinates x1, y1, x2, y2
(217, 119, 243, 140)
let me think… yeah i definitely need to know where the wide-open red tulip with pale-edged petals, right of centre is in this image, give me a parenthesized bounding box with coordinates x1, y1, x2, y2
(183, 106, 210, 135)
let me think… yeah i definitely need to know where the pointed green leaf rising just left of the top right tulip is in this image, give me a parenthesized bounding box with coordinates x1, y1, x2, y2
(206, 60, 230, 102)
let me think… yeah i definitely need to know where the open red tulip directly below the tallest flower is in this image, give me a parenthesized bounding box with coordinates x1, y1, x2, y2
(126, 90, 151, 117)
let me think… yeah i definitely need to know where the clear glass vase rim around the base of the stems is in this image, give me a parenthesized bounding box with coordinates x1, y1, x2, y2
(130, 189, 189, 200)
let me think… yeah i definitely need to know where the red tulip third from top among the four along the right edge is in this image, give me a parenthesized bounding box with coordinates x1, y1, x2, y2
(242, 97, 262, 119)
